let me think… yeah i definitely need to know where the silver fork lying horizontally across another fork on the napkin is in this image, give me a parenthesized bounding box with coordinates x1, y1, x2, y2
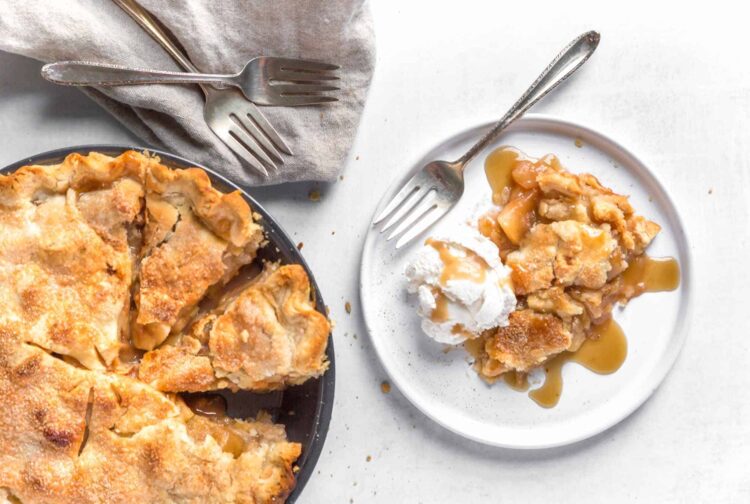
(42, 56, 340, 107)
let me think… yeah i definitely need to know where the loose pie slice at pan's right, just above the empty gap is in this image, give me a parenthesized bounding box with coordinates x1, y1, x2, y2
(139, 265, 330, 392)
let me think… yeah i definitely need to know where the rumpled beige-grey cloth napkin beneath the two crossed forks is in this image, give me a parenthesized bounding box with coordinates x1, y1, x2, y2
(0, 0, 375, 185)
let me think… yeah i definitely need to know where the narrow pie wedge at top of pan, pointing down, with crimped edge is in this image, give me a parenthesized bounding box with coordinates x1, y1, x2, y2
(133, 165, 263, 350)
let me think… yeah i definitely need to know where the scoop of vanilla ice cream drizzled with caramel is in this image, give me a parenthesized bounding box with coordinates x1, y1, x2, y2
(404, 225, 516, 345)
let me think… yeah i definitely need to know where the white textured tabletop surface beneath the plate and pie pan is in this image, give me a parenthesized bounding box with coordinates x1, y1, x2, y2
(0, 0, 750, 504)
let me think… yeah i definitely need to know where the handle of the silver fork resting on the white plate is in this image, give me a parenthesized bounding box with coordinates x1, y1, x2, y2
(454, 31, 600, 166)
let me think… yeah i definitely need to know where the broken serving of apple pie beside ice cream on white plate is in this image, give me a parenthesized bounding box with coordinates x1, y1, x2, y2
(476, 148, 660, 381)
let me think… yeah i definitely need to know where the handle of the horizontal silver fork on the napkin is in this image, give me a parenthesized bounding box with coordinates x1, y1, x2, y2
(42, 61, 237, 86)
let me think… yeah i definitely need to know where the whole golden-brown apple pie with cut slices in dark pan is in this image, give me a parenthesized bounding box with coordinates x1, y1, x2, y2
(0, 151, 330, 503)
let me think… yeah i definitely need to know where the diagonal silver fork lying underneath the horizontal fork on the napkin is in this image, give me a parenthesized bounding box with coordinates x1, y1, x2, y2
(114, 0, 292, 176)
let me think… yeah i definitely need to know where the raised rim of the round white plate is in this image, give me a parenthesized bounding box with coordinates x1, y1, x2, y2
(359, 113, 694, 450)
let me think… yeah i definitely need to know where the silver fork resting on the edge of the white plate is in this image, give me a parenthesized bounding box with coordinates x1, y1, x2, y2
(373, 31, 599, 249)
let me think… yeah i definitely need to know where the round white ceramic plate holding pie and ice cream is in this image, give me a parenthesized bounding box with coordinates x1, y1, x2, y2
(360, 115, 690, 448)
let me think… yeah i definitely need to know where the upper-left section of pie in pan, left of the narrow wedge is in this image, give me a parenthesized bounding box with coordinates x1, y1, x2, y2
(0, 153, 147, 368)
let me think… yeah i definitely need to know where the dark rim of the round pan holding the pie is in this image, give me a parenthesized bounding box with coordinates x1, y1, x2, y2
(0, 144, 336, 504)
